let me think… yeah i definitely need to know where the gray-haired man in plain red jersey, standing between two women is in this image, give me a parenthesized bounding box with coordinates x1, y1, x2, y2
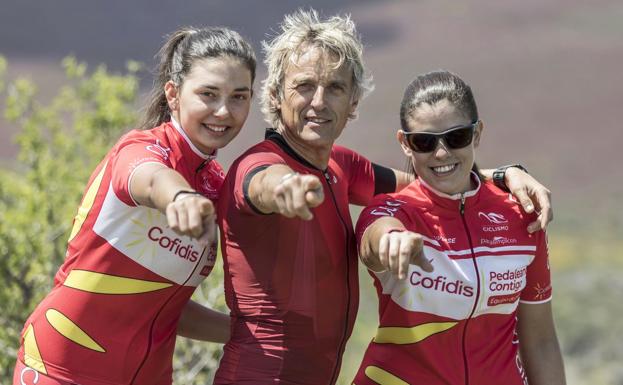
(215, 11, 551, 385)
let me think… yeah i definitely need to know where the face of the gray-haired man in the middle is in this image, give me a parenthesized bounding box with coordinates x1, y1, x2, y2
(277, 47, 357, 154)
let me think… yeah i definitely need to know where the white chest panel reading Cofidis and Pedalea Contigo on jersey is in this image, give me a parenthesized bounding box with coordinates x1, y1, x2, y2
(374, 245, 535, 320)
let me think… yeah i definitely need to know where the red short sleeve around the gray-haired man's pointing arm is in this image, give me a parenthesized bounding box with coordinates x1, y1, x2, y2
(230, 151, 286, 214)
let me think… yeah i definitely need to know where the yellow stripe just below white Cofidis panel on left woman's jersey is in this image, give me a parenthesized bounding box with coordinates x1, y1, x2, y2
(63, 270, 172, 294)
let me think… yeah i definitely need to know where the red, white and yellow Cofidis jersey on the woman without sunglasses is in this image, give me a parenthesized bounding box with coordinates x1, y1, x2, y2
(18, 122, 224, 385)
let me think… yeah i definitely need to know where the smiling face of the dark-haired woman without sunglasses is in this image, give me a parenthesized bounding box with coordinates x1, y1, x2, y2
(165, 56, 253, 154)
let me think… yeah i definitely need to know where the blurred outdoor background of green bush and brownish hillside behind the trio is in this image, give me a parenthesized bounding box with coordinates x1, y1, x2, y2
(0, 0, 623, 385)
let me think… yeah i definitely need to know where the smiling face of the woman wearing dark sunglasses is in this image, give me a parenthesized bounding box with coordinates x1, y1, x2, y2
(398, 99, 482, 195)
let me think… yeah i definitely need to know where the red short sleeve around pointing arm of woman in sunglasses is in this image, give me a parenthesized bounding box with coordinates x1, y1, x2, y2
(355, 194, 411, 247)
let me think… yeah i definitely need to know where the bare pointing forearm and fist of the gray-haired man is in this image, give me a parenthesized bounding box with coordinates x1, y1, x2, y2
(247, 164, 324, 220)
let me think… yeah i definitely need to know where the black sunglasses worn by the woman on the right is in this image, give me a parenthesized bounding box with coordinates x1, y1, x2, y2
(401, 120, 480, 152)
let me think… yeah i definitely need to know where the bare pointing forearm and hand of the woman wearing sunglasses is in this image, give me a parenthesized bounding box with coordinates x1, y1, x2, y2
(359, 217, 433, 279)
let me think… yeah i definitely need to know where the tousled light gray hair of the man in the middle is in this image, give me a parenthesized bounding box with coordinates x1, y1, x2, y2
(260, 9, 374, 127)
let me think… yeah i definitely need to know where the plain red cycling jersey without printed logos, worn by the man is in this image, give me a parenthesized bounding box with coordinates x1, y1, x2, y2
(215, 131, 375, 385)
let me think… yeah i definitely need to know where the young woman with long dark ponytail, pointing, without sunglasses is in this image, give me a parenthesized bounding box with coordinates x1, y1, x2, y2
(13, 28, 256, 385)
